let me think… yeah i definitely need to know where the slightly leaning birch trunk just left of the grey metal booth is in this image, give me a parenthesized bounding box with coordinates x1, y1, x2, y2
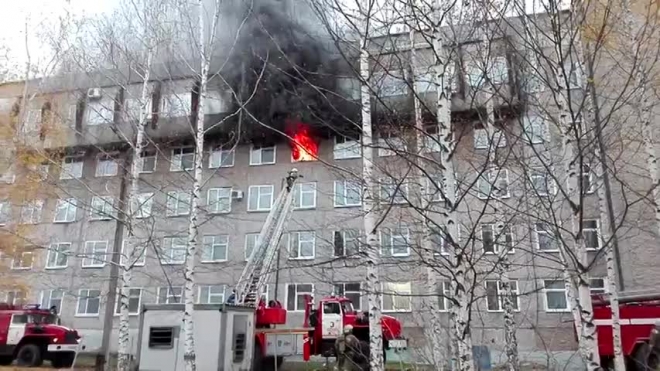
(117, 49, 153, 371)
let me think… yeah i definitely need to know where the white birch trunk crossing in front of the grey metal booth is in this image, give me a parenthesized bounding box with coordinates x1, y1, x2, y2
(183, 0, 210, 371)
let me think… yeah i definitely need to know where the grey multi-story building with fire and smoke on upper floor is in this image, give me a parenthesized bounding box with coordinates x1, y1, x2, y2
(0, 10, 656, 368)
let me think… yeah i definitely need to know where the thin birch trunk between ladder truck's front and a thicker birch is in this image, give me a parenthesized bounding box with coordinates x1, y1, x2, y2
(410, 25, 444, 370)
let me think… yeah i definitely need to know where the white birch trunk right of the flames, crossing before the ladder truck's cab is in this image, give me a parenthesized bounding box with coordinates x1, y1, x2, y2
(360, 18, 385, 371)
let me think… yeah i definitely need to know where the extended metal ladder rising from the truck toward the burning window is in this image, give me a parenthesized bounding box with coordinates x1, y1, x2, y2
(235, 169, 300, 307)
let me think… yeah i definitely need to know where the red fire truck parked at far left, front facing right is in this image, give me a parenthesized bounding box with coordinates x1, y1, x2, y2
(0, 303, 84, 368)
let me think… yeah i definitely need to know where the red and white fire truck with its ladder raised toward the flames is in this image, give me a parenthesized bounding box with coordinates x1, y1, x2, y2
(232, 169, 407, 370)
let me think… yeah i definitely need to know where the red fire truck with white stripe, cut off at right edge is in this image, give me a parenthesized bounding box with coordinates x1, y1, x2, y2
(592, 292, 660, 371)
